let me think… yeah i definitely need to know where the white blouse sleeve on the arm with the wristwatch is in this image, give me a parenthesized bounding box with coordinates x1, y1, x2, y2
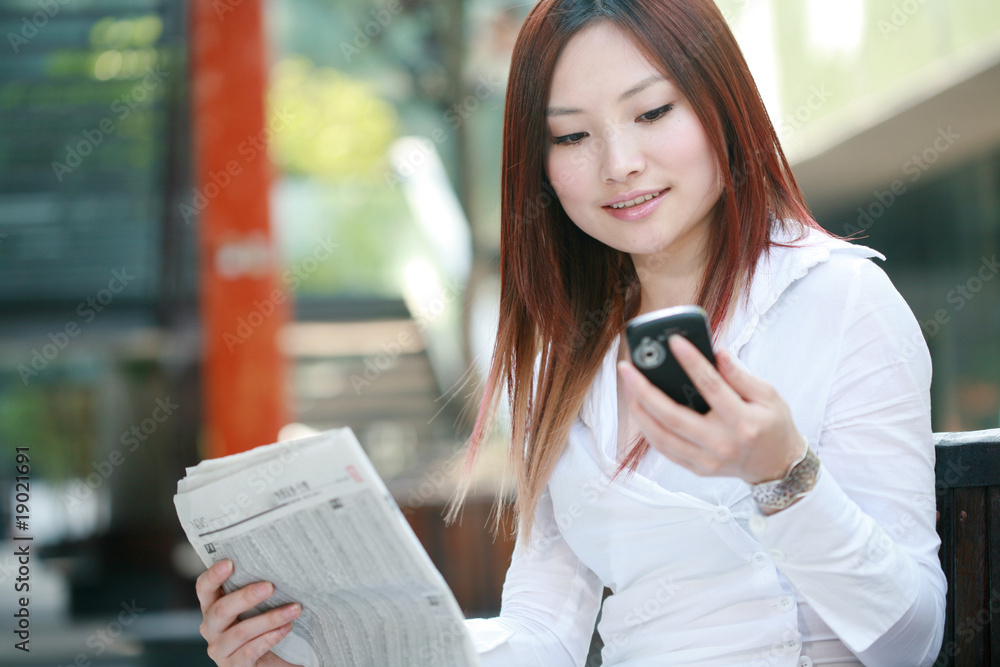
(751, 262, 946, 666)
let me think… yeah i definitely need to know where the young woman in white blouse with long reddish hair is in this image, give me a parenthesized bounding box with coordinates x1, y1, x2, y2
(198, 0, 945, 667)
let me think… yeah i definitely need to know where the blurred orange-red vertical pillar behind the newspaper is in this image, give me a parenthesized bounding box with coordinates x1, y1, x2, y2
(190, 0, 289, 457)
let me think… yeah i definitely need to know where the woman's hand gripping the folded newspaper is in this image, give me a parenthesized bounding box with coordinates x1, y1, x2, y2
(195, 560, 302, 667)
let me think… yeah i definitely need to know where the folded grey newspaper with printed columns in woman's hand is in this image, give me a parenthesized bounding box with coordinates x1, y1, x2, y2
(174, 428, 479, 667)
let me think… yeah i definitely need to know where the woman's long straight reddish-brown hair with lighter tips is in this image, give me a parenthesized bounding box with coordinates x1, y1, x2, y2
(449, 0, 820, 537)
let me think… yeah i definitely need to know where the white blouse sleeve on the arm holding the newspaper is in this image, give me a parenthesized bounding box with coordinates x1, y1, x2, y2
(466, 490, 603, 667)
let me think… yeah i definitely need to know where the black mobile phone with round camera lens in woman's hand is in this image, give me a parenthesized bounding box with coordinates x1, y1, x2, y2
(625, 306, 715, 414)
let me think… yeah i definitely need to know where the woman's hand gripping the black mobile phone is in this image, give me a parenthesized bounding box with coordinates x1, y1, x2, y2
(618, 335, 805, 484)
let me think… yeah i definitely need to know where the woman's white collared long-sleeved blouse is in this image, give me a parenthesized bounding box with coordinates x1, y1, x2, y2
(466, 226, 946, 667)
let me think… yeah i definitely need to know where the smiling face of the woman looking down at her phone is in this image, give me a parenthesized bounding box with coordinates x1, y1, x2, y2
(545, 22, 722, 268)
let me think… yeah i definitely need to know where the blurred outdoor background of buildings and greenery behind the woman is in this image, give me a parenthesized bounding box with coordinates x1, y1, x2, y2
(0, 0, 1000, 666)
